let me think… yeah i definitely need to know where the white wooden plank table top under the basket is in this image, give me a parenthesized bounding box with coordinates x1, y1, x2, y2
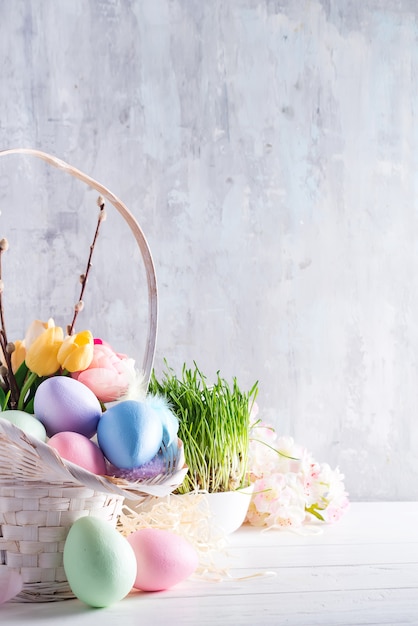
(0, 502, 418, 626)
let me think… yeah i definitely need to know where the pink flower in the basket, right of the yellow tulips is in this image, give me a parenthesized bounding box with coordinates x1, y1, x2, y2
(72, 339, 134, 402)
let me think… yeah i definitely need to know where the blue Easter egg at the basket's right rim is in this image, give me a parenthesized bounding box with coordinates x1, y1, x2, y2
(97, 400, 163, 469)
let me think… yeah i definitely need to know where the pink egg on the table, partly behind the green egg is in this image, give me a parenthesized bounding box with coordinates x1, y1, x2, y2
(127, 528, 198, 591)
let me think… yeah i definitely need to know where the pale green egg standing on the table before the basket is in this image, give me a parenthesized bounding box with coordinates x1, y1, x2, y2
(63, 516, 136, 607)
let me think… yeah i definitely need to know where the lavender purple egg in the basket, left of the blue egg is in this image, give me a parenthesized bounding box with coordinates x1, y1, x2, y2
(34, 376, 102, 438)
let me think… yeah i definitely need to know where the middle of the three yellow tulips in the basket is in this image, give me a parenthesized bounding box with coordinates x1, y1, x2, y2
(25, 326, 64, 376)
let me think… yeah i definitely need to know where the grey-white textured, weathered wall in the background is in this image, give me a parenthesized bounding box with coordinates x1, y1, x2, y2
(0, 0, 418, 499)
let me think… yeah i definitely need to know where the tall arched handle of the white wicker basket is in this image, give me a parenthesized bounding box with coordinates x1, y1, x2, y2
(0, 148, 158, 388)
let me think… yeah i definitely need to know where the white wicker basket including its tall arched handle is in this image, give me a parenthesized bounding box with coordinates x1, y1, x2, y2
(0, 148, 187, 602)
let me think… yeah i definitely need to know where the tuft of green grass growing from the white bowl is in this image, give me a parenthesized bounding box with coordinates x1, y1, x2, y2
(149, 364, 258, 493)
